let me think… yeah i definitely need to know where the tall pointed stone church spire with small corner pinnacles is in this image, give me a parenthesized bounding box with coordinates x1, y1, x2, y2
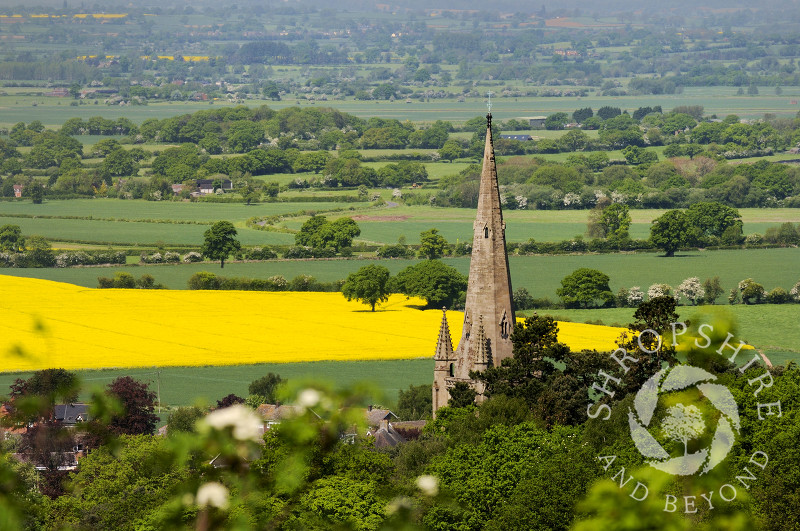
(433, 113, 515, 414)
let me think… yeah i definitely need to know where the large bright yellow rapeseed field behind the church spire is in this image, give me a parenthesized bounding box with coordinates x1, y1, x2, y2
(0, 275, 622, 371)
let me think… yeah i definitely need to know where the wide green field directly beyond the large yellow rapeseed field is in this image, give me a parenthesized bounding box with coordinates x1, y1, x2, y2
(0, 248, 800, 300)
